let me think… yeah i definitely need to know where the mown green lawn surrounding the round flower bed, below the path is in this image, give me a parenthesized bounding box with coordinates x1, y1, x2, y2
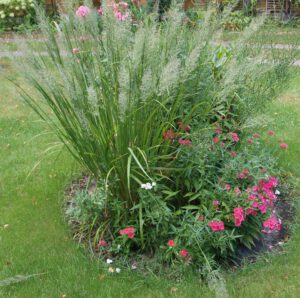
(0, 60, 300, 298)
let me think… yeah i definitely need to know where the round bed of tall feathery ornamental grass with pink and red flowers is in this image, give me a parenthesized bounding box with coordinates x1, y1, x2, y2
(22, 2, 288, 274)
